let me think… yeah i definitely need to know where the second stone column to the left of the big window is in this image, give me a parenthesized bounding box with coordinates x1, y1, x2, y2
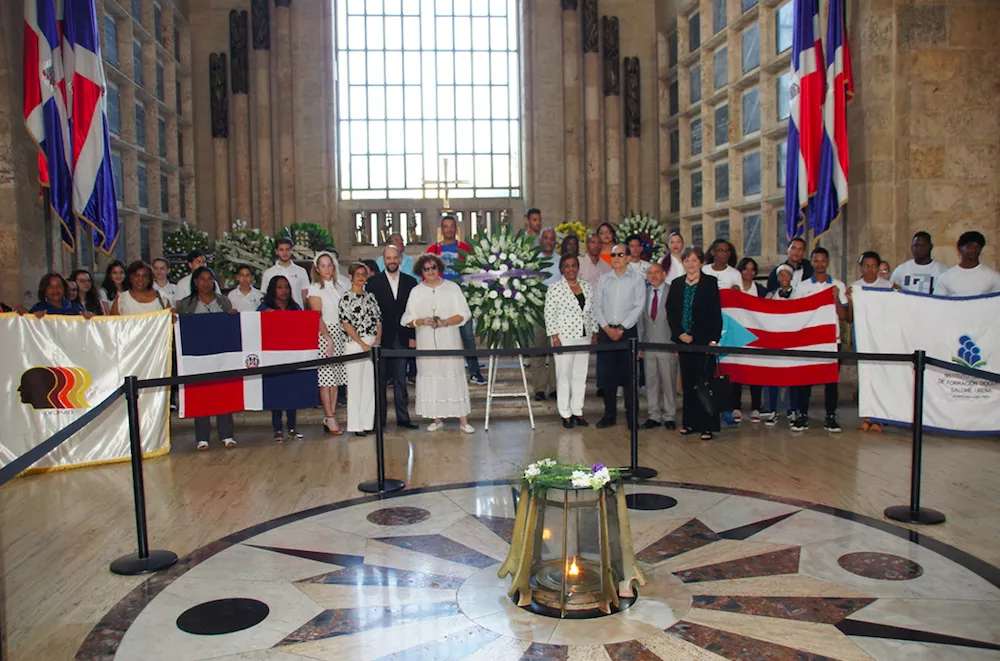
(250, 0, 275, 236)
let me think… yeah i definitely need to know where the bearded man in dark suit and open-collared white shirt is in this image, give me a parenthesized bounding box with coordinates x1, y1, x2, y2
(368, 245, 418, 429)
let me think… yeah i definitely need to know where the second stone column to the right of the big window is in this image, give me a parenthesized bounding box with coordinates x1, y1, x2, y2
(581, 0, 605, 227)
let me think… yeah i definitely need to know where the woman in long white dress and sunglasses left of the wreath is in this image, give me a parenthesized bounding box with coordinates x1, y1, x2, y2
(400, 253, 476, 434)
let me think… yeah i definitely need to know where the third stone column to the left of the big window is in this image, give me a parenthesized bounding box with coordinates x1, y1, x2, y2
(229, 9, 253, 225)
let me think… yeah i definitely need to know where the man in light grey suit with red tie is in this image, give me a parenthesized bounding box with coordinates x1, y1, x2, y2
(639, 262, 677, 429)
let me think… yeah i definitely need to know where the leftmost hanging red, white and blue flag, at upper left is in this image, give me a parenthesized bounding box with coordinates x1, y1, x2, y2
(24, 0, 76, 250)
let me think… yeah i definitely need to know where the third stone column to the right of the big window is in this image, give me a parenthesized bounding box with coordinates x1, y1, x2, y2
(602, 16, 622, 223)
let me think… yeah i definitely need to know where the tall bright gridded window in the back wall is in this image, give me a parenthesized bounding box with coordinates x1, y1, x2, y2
(336, 0, 521, 199)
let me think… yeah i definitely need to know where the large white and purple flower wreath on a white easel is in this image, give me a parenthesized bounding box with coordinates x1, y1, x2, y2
(457, 230, 551, 348)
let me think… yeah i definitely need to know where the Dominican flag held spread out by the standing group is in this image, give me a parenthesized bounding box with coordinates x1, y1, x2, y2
(174, 311, 319, 418)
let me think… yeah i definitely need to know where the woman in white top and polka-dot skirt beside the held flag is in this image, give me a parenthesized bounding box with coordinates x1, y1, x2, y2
(309, 250, 347, 436)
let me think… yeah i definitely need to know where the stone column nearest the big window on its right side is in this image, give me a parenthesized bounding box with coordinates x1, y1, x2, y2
(562, 0, 584, 222)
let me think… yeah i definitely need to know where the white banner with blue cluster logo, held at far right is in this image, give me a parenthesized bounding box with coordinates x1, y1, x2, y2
(853, 289, 1000, 434)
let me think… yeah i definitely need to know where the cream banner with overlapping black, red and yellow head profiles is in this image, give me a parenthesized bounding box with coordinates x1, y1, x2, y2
(0, 310, 171, 470)
